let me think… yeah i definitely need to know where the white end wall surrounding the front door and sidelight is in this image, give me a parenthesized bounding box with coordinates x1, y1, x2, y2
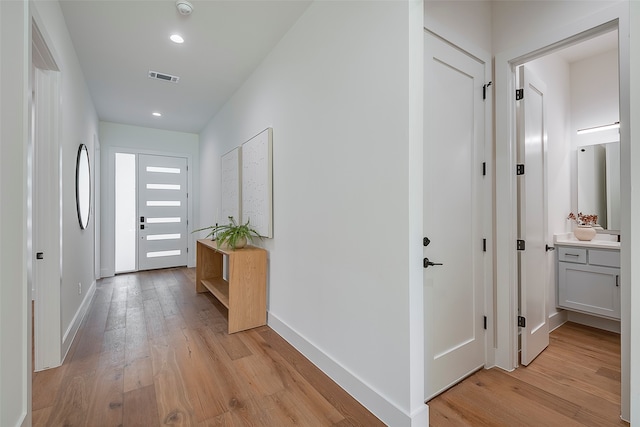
(99, 122, 199, 277)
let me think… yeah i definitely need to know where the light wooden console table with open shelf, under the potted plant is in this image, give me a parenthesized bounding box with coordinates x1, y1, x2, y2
(196, 239, 267, 334)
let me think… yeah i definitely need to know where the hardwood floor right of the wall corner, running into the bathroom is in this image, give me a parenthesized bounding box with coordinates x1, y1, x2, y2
(429, 323, 629, 427)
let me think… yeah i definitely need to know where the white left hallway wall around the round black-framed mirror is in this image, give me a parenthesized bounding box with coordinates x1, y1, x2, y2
(32, 1, 98, 362)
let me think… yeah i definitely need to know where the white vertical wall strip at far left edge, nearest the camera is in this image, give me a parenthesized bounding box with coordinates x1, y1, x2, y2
(0, 1, 31, 426)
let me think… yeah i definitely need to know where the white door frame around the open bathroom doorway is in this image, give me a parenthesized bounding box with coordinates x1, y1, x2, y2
(495, 2, 631, 420)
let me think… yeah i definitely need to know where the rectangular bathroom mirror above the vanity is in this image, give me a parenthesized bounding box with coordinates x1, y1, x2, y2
(578, 142, 620, 231)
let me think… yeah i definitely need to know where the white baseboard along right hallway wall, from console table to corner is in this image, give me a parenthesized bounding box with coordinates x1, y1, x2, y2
(267, 313, 429, 427)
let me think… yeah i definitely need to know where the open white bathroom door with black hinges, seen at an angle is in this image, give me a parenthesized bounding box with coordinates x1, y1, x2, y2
(517, 66, 549, 365)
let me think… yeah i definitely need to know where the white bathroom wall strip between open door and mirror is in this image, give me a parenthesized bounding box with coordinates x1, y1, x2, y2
(526, 54, 575, 328)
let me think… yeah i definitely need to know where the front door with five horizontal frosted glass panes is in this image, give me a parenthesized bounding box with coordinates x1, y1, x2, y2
(138, 154, 188, 270)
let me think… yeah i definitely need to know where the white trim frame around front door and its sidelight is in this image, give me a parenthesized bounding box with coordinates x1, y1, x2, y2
(100, 146, 196, 277)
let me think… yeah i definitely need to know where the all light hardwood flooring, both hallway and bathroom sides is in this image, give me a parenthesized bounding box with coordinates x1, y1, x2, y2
(33, 268, 628, 427)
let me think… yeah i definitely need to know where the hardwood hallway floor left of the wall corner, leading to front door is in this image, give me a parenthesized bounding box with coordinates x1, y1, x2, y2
(33, 268, 384, 427)
